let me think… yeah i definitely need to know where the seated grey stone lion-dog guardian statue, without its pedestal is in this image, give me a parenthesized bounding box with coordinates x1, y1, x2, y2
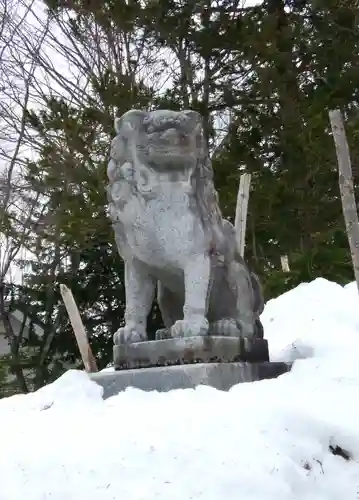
(108, 110, 263, 344)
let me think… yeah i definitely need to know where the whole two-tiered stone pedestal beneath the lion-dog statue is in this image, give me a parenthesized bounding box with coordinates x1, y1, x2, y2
(97, 336, 291, 399)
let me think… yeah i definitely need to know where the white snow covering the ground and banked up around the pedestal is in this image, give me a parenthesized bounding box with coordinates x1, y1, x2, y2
(0, 279, 359, 500)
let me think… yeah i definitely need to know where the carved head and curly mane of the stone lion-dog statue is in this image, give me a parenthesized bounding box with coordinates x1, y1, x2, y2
(107, 110, 224, 254)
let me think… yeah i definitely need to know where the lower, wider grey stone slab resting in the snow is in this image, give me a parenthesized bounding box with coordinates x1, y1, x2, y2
(90, 362, 291, 399)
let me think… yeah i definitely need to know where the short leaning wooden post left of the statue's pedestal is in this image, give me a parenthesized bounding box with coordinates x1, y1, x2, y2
(60, 284, 97, 373)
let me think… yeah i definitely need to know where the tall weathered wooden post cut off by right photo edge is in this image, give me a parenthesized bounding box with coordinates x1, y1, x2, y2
(329, 109, 359, 293)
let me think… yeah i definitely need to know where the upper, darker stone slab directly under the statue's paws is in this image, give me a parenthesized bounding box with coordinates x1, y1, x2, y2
(113, 336, 269, 370)
